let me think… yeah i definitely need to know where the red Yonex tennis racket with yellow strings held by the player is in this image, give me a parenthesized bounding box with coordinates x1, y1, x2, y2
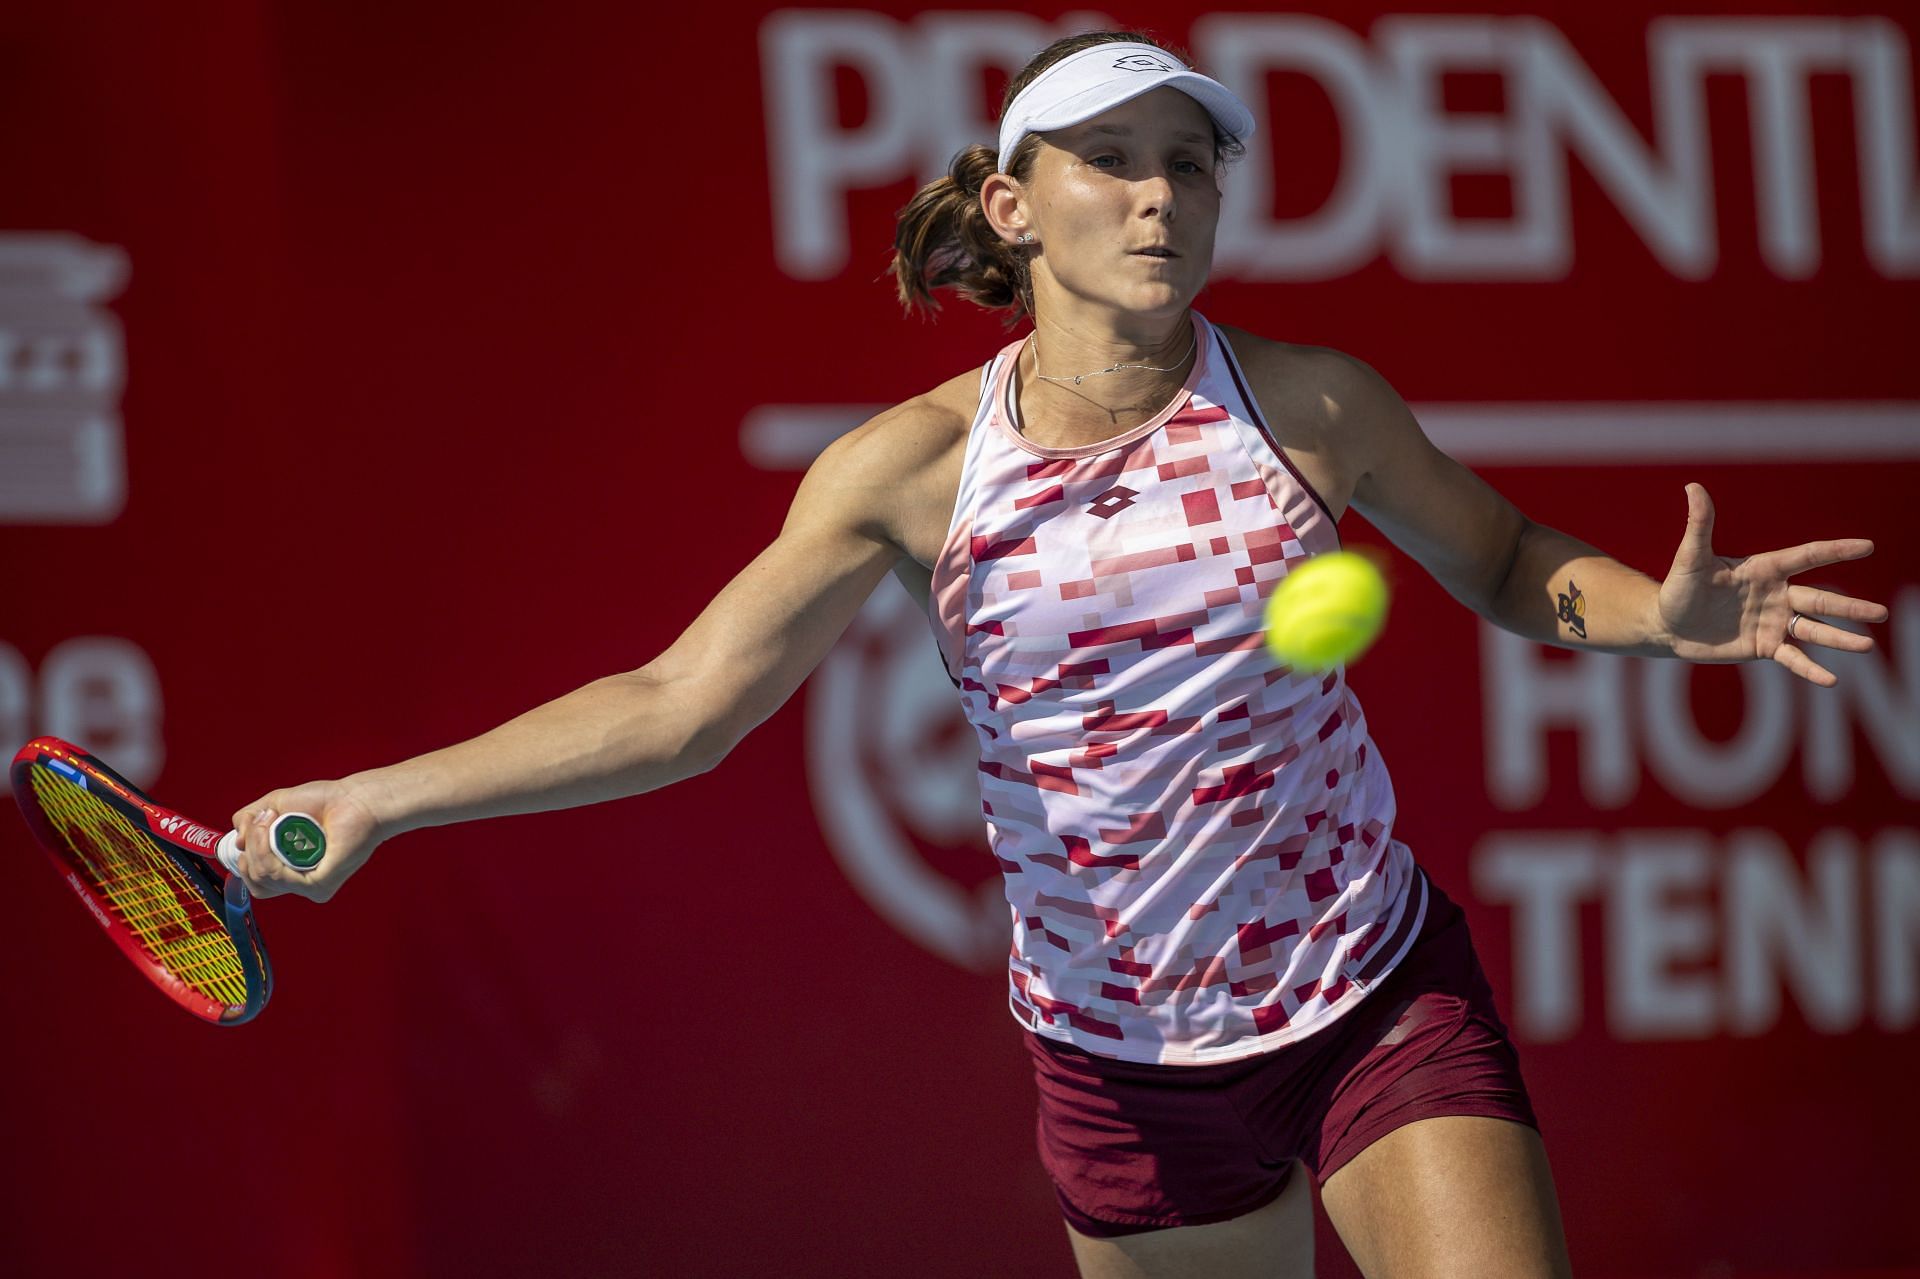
(12, 737, 326, 1026)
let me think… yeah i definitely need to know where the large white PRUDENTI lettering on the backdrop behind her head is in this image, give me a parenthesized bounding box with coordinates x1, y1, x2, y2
(760, 10, 1920, 280)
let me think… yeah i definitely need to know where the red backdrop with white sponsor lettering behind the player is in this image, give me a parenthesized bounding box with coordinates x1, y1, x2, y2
(0, 0, 1920, 1275)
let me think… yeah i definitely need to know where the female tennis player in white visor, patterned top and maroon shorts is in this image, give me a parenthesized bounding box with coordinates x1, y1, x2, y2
(234, 33, 1885, 1279)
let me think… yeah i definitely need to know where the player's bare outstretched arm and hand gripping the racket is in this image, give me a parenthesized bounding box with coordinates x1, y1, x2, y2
(234, 403, 944, 901)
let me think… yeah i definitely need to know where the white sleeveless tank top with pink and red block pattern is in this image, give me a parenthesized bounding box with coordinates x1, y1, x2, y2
(931, 313, 1427, 1064)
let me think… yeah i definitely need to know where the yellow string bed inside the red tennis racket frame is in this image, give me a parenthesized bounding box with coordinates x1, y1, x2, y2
(29, 766, 246, 1004)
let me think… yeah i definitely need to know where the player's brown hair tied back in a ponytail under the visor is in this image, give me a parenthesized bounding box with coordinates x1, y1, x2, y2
(887, 31, 1246, 328)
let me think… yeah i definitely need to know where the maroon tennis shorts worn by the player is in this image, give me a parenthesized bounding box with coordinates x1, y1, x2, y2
(1025, 868, 1540, 1237)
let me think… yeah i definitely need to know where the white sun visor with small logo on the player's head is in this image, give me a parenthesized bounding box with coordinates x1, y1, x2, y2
(1000, 42, 1254, 173)
